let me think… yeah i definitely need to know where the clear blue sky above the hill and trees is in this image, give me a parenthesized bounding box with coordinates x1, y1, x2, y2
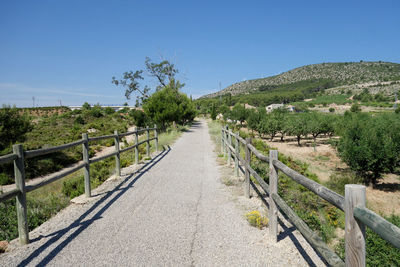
(0, 0, 400, 106)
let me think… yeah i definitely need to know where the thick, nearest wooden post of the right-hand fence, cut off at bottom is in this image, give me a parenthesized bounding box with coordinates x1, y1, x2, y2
(344, 184, 366, 266)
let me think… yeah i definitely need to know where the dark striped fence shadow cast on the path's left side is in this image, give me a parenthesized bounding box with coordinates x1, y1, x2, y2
(18, 146, 171, 266)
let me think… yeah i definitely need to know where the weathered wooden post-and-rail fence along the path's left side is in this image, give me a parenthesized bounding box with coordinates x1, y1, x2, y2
(0, 125, 158, 244)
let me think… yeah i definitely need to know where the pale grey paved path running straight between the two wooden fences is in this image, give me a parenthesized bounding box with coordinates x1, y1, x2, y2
(0, 122, 324, 266)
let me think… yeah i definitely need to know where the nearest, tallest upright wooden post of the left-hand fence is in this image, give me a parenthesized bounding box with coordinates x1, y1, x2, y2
(13, 144, 29, 245)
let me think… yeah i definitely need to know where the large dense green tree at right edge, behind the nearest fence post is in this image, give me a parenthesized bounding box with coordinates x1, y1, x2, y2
(338, 113, 400, 184)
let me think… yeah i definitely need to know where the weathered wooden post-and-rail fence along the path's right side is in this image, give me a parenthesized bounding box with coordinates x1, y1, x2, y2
(221, 126, 400, 266)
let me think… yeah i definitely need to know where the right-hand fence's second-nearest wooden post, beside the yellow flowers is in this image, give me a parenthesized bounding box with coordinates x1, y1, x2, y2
(268, 150, 278, 243)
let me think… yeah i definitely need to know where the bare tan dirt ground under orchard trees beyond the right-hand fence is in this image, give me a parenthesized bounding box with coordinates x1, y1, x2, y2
(264, 137, 400, 215)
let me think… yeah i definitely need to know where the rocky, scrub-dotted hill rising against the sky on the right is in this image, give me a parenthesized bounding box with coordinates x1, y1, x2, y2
(203, 62, 400, 98)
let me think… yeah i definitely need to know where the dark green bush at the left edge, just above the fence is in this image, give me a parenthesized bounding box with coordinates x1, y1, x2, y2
(0, 106, 32, 151)
